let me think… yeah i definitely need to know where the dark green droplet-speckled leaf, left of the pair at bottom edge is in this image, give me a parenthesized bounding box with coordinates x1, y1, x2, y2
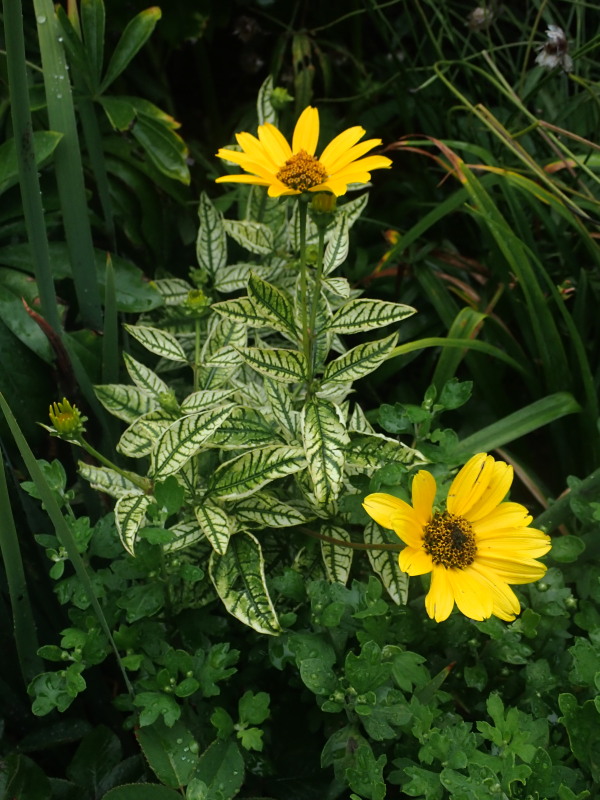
(137, 718, 199, 789)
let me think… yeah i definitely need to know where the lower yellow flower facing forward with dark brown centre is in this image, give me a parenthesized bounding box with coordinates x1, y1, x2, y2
(364, 453, 552, 622)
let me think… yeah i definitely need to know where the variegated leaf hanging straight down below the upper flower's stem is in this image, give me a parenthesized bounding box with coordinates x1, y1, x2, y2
(302, 398, 350, 506)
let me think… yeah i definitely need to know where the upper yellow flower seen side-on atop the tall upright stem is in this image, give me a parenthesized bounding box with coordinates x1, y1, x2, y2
(217, 106, 392, 197)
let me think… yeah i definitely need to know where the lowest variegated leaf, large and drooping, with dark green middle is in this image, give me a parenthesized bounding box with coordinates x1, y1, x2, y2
(208, 533, 281, 636)
